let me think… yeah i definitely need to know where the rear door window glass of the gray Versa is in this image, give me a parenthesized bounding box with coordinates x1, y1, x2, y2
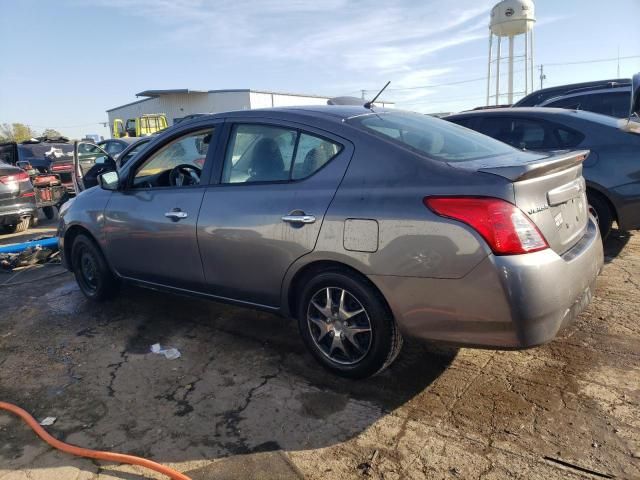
(222, 124, 342, 183)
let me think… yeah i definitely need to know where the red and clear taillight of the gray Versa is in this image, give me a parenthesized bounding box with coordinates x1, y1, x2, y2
(423, 197, 549, 255)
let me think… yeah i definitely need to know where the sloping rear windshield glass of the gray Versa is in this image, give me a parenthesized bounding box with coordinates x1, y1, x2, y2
(348, 112, 514, 162)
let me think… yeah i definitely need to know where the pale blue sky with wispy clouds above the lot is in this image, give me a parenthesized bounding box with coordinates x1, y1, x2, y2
(0, 0, 640, 138)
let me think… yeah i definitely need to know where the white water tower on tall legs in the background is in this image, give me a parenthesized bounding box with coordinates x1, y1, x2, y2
(487, 0, 536, 105)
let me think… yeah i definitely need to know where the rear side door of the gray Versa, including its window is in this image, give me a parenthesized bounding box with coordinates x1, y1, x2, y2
(198, 120, 353, 307)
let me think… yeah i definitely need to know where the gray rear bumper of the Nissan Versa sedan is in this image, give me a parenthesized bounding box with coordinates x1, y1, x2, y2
(369, 218, 604, 348)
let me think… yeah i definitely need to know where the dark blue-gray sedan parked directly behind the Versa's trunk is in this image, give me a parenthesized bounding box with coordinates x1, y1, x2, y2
(446, 107, 640, 238)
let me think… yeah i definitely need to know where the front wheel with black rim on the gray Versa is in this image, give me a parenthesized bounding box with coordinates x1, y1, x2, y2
(71, 234, 119, 302)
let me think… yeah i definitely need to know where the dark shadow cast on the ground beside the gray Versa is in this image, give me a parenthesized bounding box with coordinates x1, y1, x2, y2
(0, 277, 457, 478)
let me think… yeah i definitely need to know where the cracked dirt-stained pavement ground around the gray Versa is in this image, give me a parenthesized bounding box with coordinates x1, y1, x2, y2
(0, 218, 640, 480)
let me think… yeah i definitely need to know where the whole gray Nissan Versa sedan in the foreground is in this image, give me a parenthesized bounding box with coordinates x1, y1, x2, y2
(59, 105, 603, 377)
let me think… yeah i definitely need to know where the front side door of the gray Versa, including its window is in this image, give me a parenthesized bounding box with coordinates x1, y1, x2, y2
(104, 122, 219, 290)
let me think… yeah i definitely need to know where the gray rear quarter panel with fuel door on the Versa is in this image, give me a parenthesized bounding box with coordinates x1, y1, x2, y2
(289, 133, 513, 292)
